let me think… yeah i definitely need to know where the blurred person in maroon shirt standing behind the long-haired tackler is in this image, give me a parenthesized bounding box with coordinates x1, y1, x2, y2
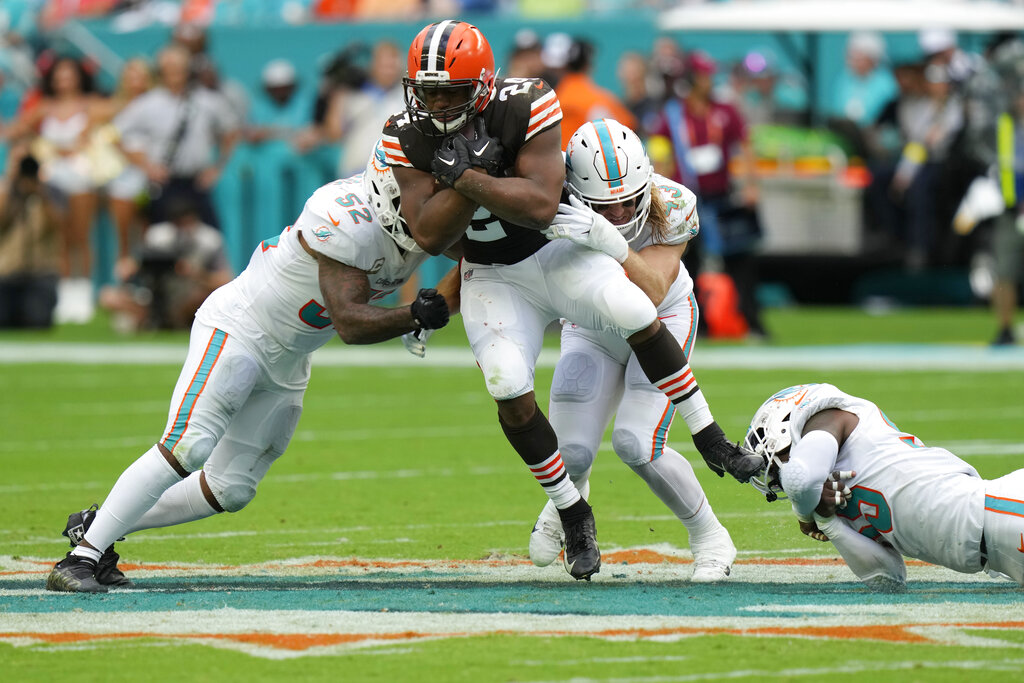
(652, 50, 767, 337)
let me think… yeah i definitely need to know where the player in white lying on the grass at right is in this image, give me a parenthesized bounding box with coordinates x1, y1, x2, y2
(745, 384, 1024, 591)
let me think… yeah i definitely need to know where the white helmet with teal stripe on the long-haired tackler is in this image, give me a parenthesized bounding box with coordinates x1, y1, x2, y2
(565, 119, 654, 240)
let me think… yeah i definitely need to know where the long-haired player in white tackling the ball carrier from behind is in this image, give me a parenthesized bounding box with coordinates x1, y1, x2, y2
(529, 119, 736, 583)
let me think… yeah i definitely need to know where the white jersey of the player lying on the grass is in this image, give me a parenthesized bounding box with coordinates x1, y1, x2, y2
(790, 384, 985, 573)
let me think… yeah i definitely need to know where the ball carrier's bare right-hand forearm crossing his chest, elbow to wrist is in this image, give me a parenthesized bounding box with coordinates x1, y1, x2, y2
(455, 170, 559, 230)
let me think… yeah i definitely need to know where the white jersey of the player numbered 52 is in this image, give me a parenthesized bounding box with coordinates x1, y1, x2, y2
(196, 175, 427, 385)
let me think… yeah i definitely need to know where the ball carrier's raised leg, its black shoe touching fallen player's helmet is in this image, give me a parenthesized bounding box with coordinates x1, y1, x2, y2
(546, 241, 761, 481)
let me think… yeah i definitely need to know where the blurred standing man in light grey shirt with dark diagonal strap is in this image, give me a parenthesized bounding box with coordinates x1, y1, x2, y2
(117, 45, 239, 231)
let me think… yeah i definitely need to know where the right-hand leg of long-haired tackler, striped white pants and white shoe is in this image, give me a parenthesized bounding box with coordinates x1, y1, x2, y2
(611, 356, 736, 583)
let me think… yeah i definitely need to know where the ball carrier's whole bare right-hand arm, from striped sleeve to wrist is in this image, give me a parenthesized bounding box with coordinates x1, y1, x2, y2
(448, 126, 565, 230)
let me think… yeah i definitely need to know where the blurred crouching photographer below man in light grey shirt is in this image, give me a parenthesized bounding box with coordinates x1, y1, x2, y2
(99, 198, 231, 333)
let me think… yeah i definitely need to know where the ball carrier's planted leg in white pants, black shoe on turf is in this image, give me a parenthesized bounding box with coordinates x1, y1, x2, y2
(461, 258, 600, 579)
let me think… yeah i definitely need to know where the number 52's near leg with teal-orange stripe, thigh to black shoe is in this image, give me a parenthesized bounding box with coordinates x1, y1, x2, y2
(47, 323, 260, 592)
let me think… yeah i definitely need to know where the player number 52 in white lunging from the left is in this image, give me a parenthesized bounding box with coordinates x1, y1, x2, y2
(46, 146, 458, 592)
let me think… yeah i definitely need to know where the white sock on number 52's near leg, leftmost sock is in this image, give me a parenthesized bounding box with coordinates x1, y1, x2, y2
(85, 445, 181, 550)
